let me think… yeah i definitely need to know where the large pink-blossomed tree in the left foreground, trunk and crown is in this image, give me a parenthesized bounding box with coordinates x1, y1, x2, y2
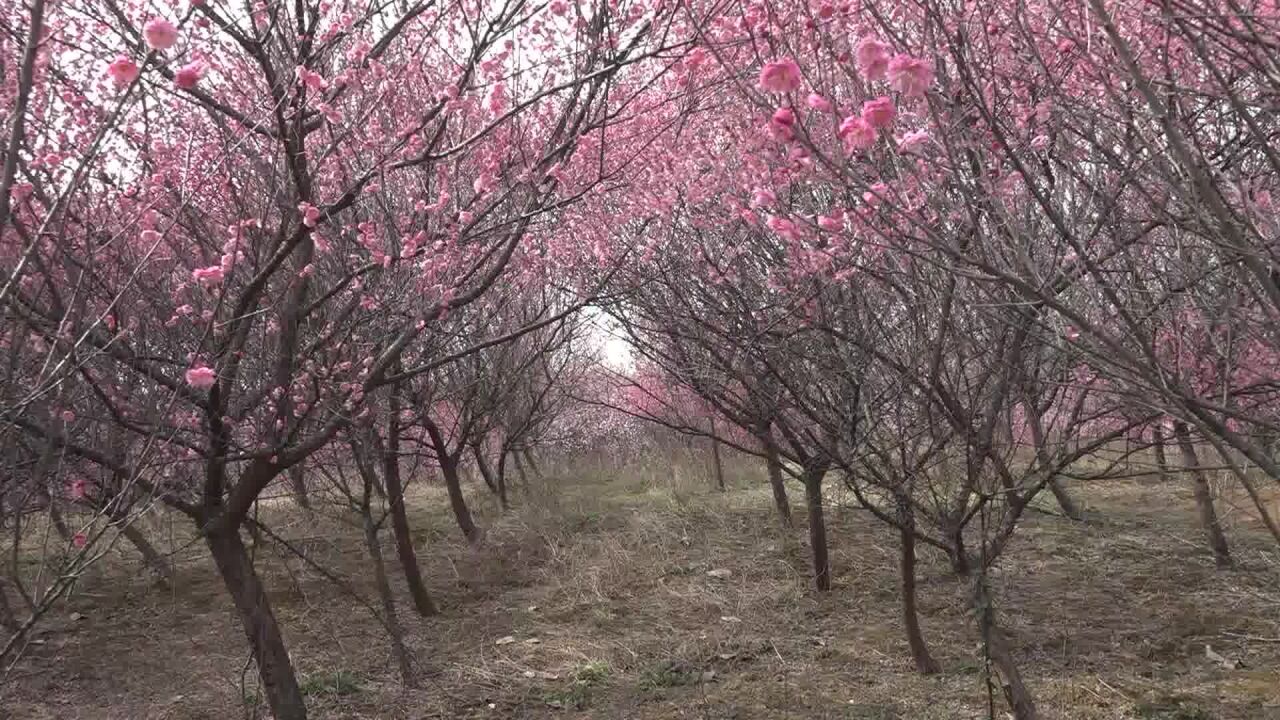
(0, 0, 686, 719)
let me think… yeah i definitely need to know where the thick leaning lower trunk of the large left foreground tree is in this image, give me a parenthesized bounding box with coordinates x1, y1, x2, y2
(205, 529, 307, 720)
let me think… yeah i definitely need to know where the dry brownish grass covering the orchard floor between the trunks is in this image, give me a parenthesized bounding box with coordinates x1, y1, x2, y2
(0, 453, 1280, 720)
